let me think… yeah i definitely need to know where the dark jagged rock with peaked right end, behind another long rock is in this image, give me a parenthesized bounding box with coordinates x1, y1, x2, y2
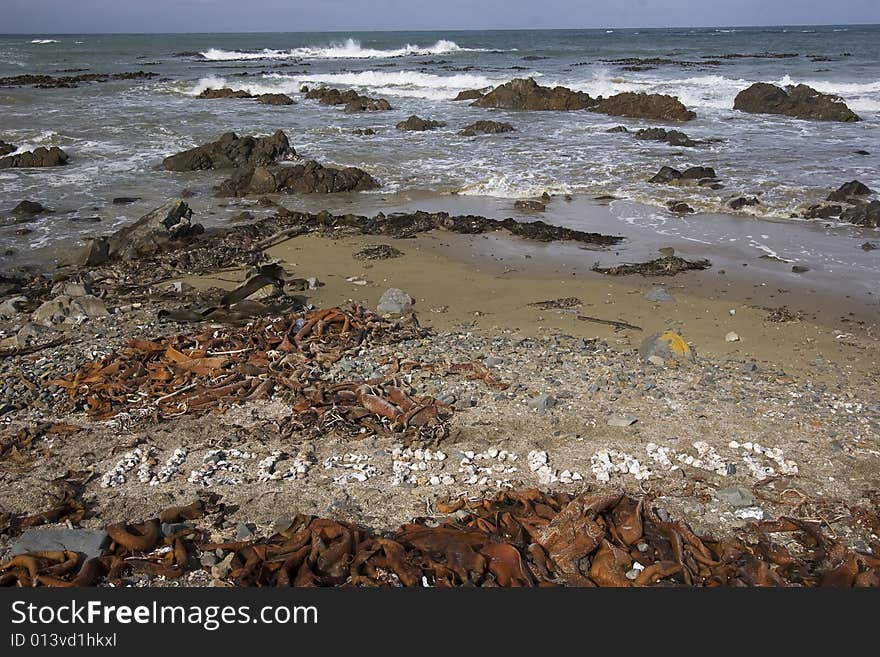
(162, 130, 296, 171)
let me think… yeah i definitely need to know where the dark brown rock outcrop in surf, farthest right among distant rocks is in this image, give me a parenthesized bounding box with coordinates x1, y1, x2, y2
(733, 82, 862, 122)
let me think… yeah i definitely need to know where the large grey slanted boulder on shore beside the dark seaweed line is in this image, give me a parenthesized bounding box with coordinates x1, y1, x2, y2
(108, 200, 205, 258)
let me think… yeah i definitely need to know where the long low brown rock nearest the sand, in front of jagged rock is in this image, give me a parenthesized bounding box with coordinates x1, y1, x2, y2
(217, 160, 379, 196)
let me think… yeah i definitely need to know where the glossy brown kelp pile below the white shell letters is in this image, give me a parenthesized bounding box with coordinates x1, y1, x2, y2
(0, 489, 880, 587)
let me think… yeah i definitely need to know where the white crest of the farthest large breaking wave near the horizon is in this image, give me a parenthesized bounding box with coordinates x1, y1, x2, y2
(199, 39, 502, 61)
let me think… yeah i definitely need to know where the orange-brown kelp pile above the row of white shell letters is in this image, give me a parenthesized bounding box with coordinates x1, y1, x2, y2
(50, 306, 452, 439)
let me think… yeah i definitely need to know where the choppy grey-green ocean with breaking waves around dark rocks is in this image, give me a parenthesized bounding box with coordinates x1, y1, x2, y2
(0, 26, 880, 290)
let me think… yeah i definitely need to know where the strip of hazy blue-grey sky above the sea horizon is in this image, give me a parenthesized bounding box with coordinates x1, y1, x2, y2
(0, 0, 880, 34)
